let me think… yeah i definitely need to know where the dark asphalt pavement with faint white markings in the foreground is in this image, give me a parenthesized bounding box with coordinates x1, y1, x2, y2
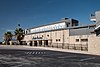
(0, 47, 100, 67)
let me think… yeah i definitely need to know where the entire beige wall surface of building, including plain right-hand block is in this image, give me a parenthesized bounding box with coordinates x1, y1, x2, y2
(24, 30, 100, 55)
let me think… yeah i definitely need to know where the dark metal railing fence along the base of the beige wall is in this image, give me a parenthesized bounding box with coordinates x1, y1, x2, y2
(35, 43, 88, 51)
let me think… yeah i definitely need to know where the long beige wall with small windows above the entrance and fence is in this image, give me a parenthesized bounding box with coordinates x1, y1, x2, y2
(24, 30, 88, 44)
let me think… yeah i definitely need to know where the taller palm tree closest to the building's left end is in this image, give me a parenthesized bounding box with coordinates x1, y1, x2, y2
(15, 28, 24, 44)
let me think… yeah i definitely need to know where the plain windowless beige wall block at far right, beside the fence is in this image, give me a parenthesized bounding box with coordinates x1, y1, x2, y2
(88, 34, 100, 55)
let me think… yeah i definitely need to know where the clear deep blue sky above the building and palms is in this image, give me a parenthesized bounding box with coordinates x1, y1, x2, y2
(0, 0, 100, 40)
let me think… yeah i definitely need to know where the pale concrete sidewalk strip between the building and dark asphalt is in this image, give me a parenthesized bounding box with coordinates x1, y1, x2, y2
(0, 45, 98, 55)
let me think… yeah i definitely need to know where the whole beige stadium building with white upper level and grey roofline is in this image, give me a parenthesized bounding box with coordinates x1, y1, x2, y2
(23, 11, 100, 55)
